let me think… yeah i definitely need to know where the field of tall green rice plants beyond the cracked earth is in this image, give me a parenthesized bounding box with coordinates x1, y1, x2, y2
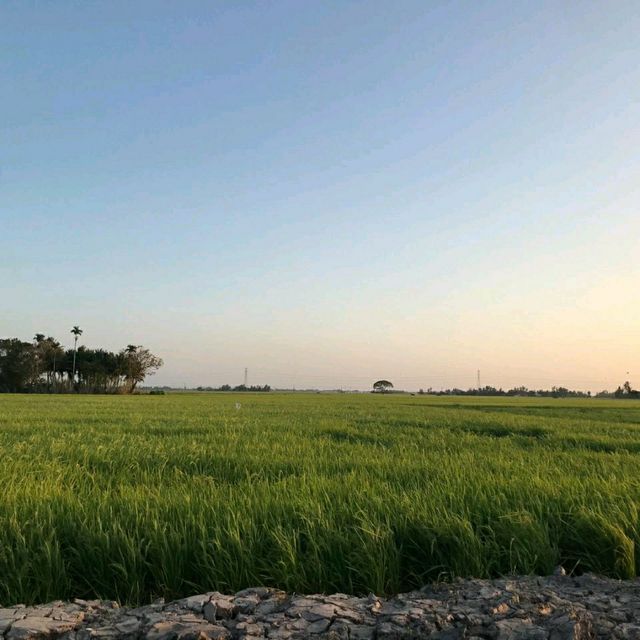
(0, 393, 640, 605)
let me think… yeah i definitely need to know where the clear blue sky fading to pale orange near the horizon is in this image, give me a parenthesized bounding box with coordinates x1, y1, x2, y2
(0, 0, 640, 391)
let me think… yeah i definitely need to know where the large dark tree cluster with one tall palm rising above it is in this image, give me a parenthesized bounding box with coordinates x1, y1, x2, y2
(0, 326, 163, 393)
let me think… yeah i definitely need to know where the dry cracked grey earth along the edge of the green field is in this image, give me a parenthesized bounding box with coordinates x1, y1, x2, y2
(0, 575, 640, 640)
